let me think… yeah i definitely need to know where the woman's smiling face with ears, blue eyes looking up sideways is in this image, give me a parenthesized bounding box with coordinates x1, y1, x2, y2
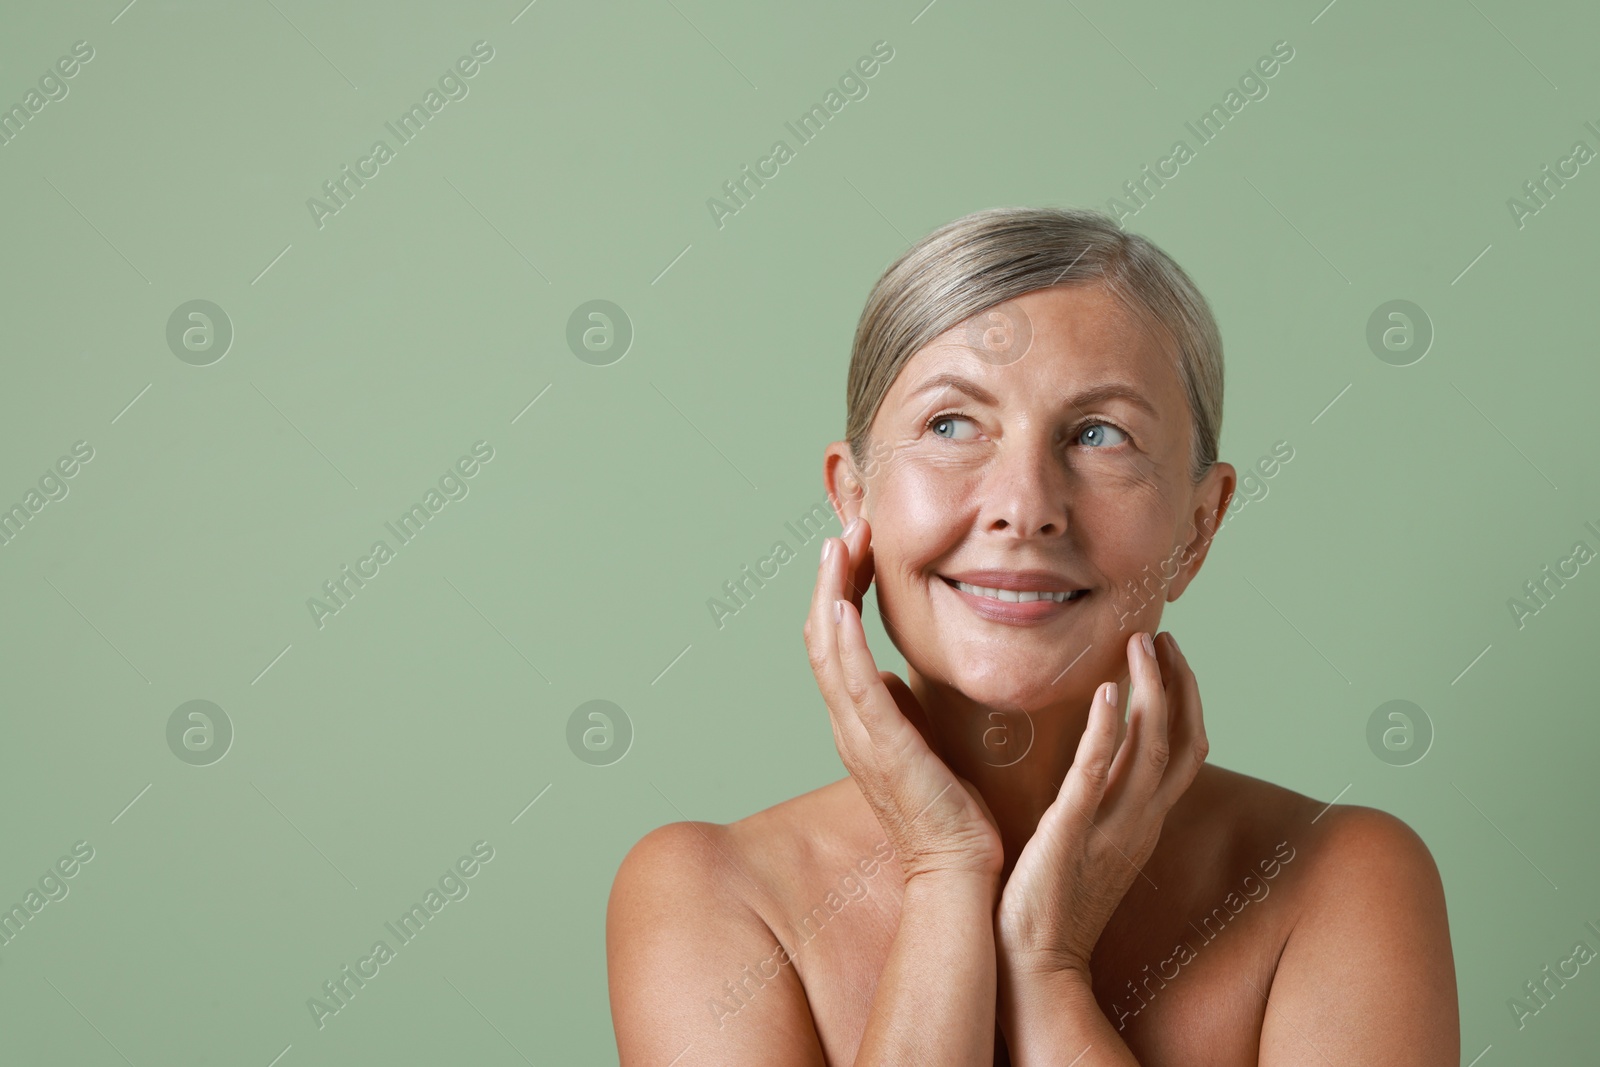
(826, 285, 1234, 710)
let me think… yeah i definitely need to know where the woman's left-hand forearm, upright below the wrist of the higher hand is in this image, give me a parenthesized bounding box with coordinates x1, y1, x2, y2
(856, 875, 998, 1067)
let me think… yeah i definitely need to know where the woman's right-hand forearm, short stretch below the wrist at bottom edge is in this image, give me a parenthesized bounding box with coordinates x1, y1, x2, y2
(997, 971, 1139, 1067)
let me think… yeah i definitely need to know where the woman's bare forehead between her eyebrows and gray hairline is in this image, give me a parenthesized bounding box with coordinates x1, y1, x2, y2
(886, 283, 1182, 414)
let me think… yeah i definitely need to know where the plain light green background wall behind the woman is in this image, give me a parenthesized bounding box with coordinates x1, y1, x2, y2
(0, 0, 1600, 1067)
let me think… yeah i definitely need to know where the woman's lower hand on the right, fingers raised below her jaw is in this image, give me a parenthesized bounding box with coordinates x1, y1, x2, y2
(995, 633, 1208, 981)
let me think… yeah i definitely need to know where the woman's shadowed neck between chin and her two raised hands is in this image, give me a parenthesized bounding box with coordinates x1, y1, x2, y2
(907, 669, 1128, 881)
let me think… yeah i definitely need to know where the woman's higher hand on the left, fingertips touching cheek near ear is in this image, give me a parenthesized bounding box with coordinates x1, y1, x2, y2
(805, 518, 1005, 888)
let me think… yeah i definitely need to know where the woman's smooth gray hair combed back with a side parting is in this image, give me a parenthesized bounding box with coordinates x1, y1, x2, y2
(845, 208, 1222, 485)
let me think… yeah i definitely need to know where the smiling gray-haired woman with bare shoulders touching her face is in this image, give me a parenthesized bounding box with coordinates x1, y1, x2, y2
(606, 208, 1459, 1067)
